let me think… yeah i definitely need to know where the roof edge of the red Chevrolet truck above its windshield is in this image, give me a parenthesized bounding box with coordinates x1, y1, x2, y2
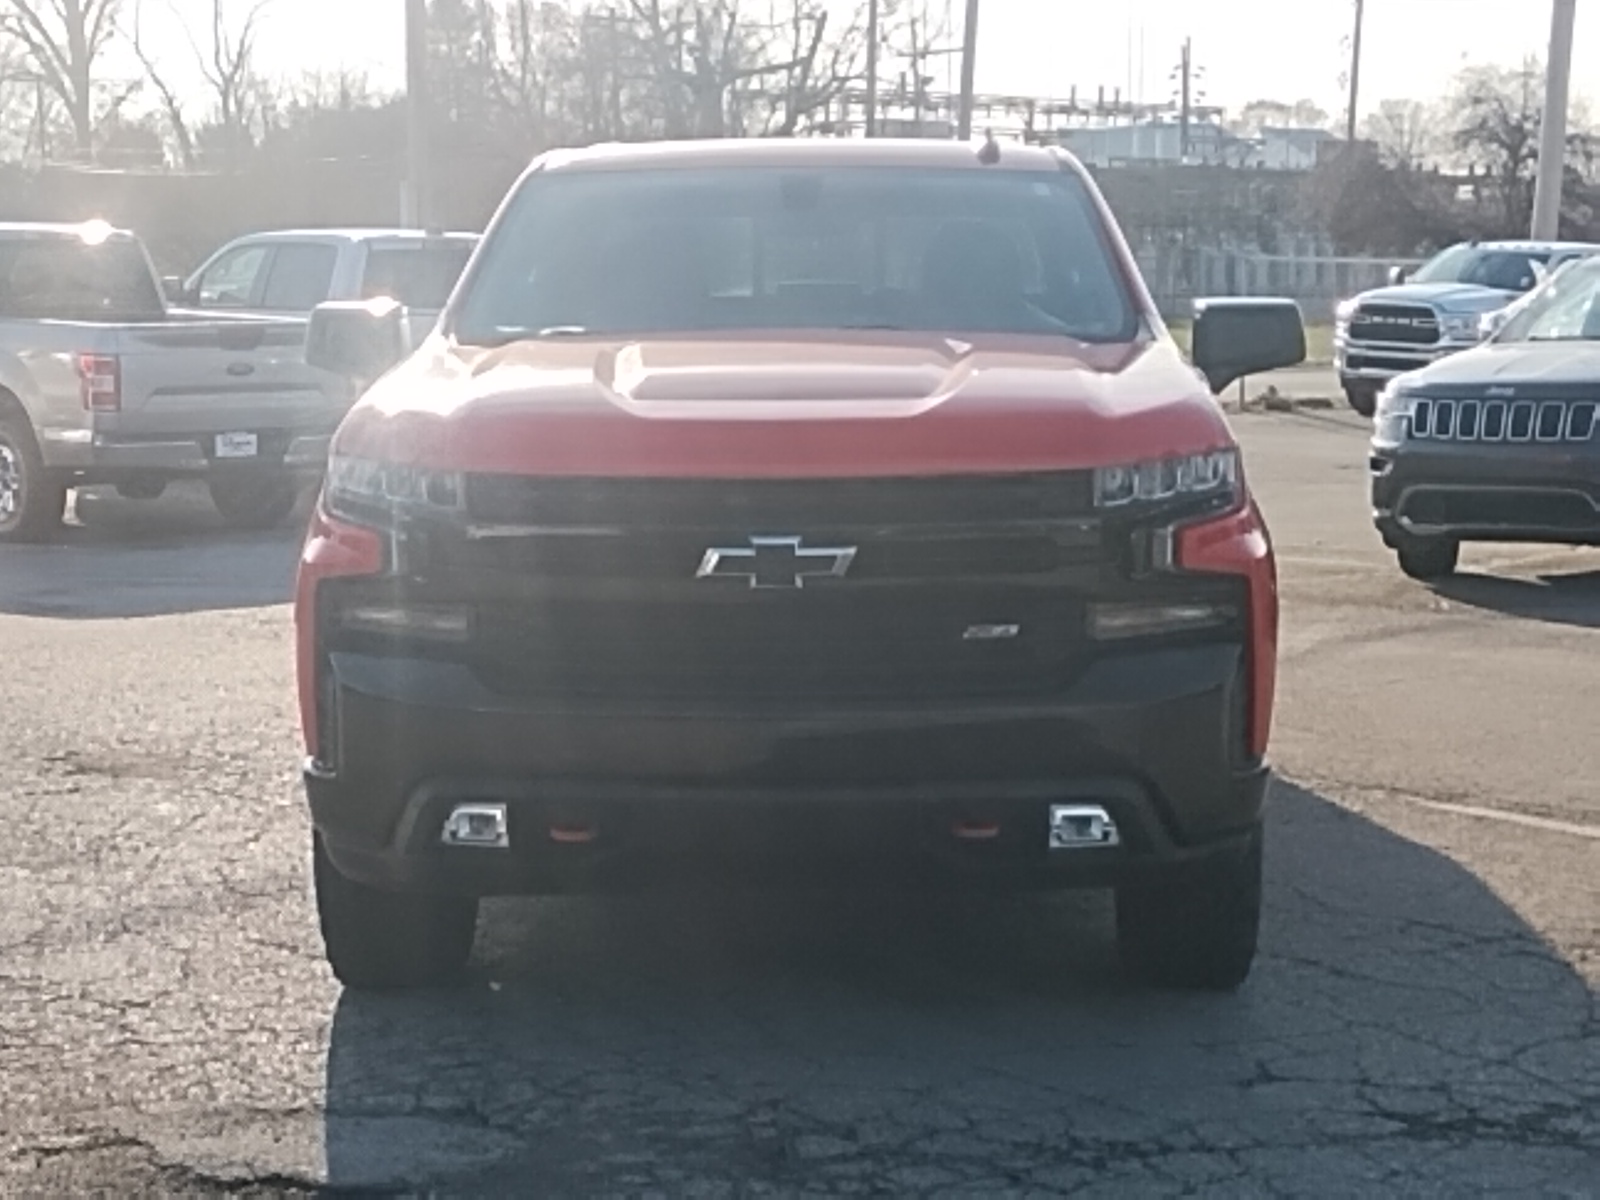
(534, 138, 1077, 171)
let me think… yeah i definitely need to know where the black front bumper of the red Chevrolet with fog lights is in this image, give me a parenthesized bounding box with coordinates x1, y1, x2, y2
(306, 645, 1266, 894)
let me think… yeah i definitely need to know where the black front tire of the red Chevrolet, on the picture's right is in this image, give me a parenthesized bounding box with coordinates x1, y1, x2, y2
(1117, 829, 1261, 992)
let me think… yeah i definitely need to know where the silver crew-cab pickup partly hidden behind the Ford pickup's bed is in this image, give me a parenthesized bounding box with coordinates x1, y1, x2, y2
(172, 229, 477, 341)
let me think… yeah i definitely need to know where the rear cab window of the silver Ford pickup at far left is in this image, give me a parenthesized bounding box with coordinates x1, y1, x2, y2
(0, 235, 166, 322)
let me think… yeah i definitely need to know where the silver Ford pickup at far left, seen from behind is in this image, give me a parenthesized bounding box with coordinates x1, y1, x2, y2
(0, 222, 354, 541)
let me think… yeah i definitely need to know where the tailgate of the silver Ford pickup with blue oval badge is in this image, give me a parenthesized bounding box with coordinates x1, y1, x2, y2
(94, 317, 354, 456)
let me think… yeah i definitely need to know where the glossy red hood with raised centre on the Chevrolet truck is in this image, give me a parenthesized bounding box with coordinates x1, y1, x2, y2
(334, 333, 1232, 478)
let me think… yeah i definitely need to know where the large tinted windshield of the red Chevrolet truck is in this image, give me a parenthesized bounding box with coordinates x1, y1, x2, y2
(453, 166, 1138, 344)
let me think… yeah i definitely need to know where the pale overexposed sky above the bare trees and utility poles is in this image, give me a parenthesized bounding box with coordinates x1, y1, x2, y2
(130, 0, 1600, 123)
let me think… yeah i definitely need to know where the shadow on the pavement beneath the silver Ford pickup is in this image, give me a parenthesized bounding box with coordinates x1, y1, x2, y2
(0, 496, 304, 621)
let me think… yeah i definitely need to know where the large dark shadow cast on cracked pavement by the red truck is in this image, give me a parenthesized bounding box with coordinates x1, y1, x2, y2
(325, 784, 1600, 1195)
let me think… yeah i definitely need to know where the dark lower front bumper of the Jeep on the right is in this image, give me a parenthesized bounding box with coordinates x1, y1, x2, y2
(1370, 442, 1600, 546)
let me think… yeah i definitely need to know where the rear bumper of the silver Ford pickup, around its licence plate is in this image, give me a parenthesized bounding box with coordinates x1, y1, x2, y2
(40, 430, 333, 483)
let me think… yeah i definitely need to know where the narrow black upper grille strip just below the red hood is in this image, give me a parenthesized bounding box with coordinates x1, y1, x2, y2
(467, 470, 1094, 533)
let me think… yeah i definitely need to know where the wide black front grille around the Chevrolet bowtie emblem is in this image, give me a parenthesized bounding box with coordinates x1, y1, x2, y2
(360, 472, 1238, 710)
